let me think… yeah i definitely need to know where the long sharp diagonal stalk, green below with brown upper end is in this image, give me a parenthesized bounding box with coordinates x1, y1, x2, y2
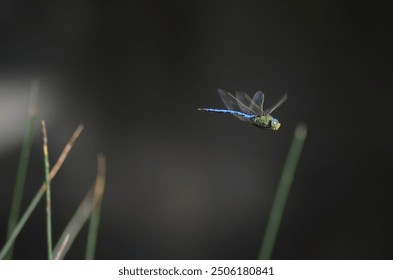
(0, 125, 83, 260)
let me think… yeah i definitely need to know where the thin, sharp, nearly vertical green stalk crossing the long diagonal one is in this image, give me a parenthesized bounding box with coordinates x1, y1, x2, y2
(41, 120, 53, 260)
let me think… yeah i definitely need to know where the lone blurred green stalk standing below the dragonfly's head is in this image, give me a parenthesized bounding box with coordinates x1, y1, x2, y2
(259, 124, 307, 260)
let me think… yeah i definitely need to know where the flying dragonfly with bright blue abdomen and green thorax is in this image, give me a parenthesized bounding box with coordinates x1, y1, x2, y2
(198, 89, 288, 130)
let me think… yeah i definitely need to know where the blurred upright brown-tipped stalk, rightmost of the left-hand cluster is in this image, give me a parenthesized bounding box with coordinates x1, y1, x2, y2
(85, 155, 106, 260)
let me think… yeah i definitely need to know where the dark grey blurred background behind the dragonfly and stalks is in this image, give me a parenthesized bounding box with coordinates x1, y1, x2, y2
(0, 0, 393, 259)
